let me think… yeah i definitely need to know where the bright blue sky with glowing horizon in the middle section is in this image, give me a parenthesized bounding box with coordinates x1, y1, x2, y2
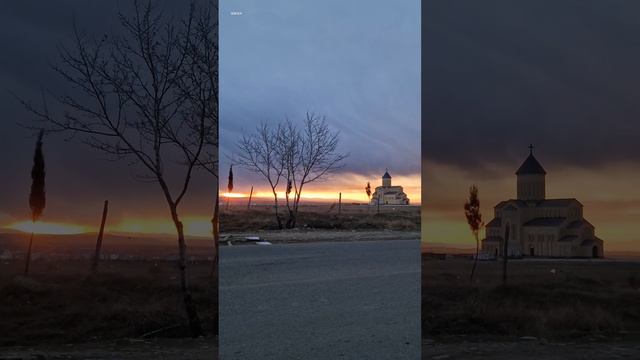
(220, 0, 421, 204)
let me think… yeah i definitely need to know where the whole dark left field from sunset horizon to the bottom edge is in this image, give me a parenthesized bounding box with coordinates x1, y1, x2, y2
(0, 233, 218, 359)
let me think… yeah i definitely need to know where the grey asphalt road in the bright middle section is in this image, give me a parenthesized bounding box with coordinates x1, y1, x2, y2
(219, 240, 421, 360)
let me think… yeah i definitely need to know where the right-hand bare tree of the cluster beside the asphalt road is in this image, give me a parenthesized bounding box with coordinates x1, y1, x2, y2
(284, 113, 348, 228)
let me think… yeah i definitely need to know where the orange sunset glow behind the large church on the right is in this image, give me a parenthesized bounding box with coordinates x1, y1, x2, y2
(422, 162, 640, 252)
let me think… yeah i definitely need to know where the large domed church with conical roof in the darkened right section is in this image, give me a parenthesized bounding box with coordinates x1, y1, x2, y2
(482, 146, 604, 258)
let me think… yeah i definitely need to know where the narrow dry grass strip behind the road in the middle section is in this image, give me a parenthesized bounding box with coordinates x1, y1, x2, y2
(220, 205, 420, 232)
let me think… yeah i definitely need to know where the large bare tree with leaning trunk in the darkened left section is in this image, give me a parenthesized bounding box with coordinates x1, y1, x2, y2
(18, 0, 218, 336)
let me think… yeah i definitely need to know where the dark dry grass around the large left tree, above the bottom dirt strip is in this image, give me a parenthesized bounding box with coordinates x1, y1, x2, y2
(0, 261, 217, 346)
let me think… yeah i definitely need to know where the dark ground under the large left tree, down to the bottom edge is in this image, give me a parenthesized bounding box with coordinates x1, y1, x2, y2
(0, 260, 217, 359)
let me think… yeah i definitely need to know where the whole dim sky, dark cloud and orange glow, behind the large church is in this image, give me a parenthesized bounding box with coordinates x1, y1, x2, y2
(422, 0, 640, 251)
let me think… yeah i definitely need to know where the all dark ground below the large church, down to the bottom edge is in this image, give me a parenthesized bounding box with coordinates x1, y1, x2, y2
(422, 257, 640, 359)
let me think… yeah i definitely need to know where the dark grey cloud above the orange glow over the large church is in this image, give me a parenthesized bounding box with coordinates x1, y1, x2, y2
(422, 0, 640, 169)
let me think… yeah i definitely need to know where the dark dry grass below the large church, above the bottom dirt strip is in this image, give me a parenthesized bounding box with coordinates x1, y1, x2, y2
(422, 258, 640, 339)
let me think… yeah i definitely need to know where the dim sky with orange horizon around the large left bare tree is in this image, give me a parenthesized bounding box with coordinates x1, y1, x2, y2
(0, 0, 215, 235)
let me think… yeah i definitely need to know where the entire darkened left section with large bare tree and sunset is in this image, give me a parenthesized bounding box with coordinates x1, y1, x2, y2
(0, 0, 218, 359)
